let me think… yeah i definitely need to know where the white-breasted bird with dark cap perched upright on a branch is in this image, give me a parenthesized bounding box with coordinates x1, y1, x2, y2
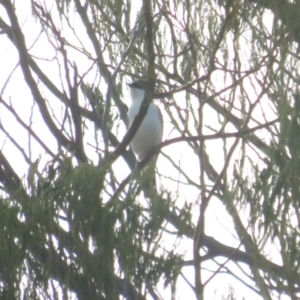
(127, 80, 163, 198)
